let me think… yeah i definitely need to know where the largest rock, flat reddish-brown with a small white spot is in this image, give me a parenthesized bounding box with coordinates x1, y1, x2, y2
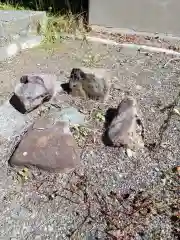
(10, 119, 80, 171)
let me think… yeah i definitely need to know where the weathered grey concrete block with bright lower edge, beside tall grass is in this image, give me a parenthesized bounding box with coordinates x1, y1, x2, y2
(0, 10, 46, 61)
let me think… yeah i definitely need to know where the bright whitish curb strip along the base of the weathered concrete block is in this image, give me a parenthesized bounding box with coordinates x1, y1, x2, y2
(0, 36, 43, 62)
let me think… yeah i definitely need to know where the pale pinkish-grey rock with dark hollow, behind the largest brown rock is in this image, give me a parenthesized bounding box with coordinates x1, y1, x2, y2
(10, 74, 61, 113)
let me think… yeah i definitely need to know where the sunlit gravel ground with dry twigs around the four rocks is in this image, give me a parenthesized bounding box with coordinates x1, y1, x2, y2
(0, 40, 180, 240)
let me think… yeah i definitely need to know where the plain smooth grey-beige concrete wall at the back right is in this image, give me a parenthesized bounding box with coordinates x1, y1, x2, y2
(89, 0, 180, 35)
